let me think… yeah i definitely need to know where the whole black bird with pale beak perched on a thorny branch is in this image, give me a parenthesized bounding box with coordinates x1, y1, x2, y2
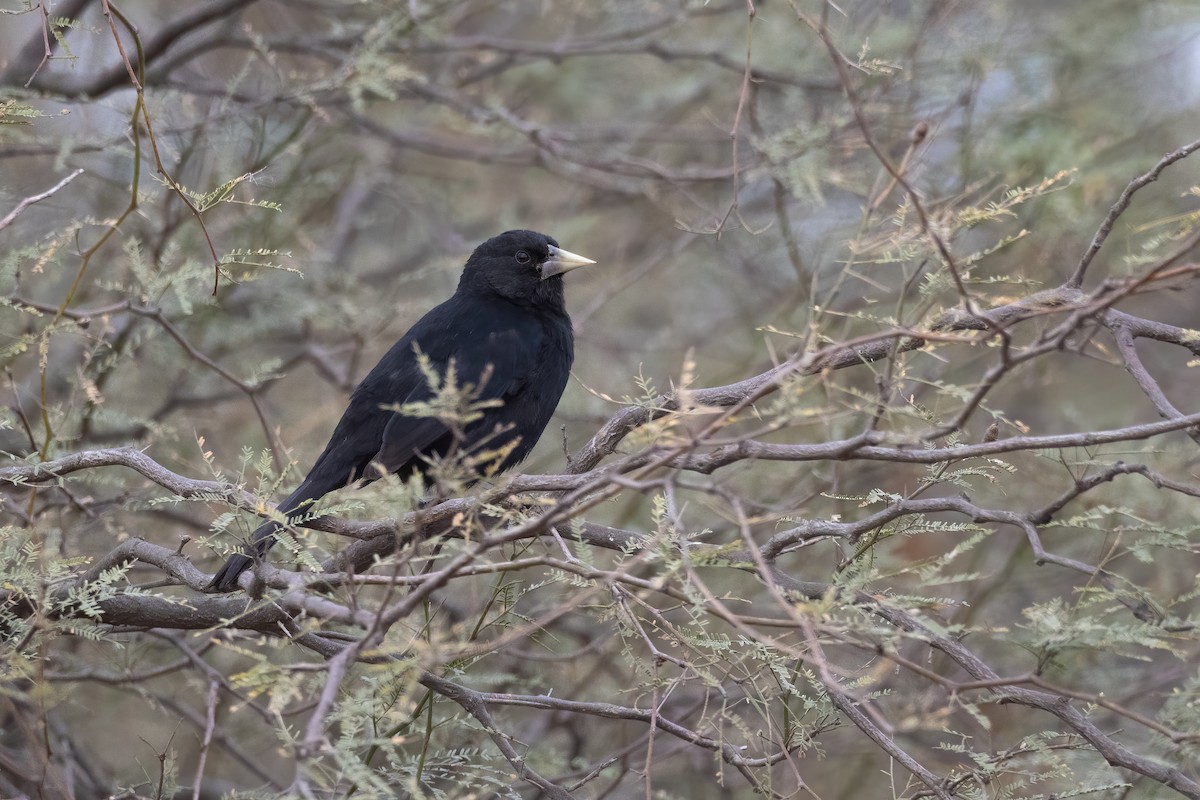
(209, 230, 595, 591)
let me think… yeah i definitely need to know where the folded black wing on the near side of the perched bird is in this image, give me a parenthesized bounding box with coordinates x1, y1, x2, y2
(373, 325, 542, 473)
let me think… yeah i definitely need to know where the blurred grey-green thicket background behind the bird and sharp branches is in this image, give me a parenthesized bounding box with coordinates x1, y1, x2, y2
(0, 0, 1200, 799)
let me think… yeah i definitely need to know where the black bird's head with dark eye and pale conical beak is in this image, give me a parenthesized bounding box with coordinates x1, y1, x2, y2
(458, 230, 595, 309)
